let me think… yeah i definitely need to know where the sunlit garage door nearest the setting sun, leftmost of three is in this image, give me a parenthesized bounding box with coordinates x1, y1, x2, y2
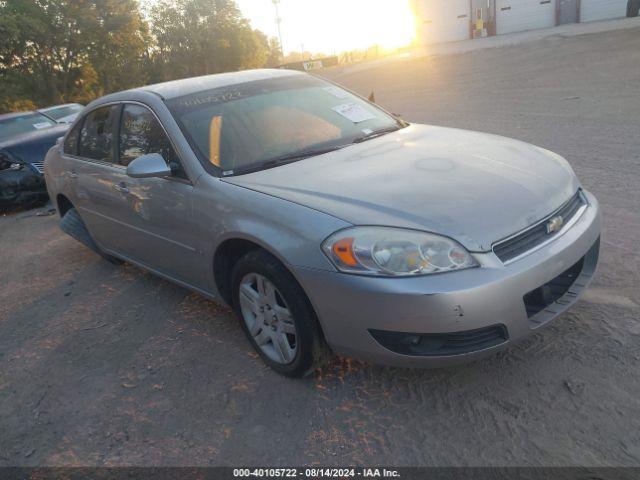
(414, 0, 471, 44)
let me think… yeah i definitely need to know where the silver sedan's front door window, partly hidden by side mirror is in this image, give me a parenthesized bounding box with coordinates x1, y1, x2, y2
(120, 104, 187, 179)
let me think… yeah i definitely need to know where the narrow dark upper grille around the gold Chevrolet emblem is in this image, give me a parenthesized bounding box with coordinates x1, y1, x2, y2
(493, 191, 586, 263)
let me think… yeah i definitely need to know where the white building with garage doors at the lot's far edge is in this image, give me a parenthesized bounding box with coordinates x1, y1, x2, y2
(410, 0, 635, 45)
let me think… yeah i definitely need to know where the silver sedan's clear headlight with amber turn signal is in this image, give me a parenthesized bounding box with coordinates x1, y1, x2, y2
(322, 227, 478, 276)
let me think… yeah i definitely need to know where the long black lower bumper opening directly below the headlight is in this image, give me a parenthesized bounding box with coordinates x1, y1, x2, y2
(369, 325, 509, 357)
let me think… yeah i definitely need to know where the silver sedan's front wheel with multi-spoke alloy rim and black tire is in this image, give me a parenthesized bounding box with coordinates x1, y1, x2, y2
(231, 250, 330, 377)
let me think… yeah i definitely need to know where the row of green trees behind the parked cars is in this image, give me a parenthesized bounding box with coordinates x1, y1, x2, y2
(0, 0, 280, 113)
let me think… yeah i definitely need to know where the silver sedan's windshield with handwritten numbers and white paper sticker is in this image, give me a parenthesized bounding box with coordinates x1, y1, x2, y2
(167, 75, 400, 175)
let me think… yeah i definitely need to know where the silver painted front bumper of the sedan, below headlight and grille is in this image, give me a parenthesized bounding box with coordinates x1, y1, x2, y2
(294, 188, 600, 367)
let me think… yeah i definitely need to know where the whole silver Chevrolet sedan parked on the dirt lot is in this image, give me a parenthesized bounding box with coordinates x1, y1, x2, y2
(45, 70, 600, 376)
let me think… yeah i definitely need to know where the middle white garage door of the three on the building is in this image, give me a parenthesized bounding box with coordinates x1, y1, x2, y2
(496, 0, 556, 35)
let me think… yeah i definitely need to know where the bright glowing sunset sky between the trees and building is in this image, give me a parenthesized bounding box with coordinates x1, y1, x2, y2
(236, 0, 414, 55)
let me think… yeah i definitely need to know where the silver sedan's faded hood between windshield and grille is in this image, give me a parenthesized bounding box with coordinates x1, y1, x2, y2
(224, 125, 579, 252)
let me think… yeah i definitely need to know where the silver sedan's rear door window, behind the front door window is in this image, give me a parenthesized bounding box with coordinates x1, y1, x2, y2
(78, 105, 120, 163)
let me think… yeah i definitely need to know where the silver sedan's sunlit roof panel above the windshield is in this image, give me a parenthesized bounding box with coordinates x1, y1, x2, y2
(133, 69, 304, 99)
